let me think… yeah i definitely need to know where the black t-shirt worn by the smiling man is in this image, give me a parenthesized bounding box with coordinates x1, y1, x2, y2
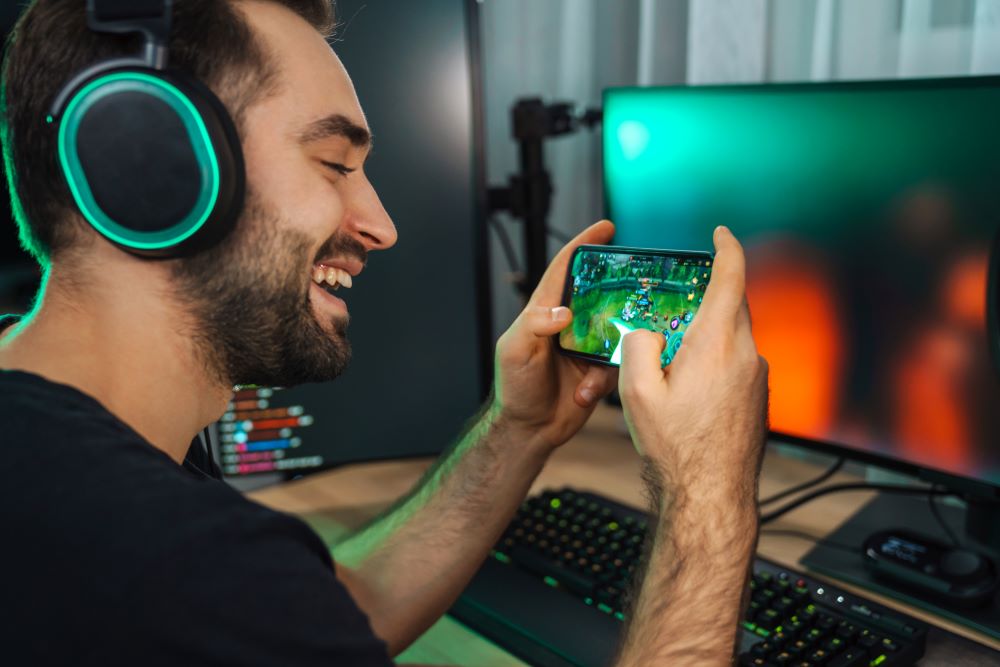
(0, 362, 391, 667)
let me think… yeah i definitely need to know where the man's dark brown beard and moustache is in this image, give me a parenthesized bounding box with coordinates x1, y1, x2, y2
(173, 196, 367, 387)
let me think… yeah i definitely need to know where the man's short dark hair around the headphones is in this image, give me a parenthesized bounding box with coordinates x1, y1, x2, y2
(0, 0, 333, 266)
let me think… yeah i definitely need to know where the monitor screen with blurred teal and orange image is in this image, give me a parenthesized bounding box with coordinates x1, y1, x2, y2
(604, 77, 1000, 484)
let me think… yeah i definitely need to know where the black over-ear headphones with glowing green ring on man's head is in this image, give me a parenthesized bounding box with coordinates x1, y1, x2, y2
(45, 0, 246, 258)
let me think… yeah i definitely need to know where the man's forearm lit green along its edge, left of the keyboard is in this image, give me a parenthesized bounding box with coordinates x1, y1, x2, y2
(334, 410, 549, 655)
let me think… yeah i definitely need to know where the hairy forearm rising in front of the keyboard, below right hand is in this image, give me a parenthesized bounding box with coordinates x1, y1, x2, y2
(618, 462, 757, 667)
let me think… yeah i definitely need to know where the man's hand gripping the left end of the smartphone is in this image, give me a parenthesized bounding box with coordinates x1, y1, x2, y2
(493, 220, 618, 448)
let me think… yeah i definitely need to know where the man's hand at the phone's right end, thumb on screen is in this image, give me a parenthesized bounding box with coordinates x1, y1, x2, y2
(619, 227, 767, 499)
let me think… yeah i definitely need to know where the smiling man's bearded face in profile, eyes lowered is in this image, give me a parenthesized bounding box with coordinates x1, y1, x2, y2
(175, 0, 396, 386)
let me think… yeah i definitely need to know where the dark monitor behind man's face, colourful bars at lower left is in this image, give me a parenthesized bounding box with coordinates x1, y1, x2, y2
(218, 0, 492, 479)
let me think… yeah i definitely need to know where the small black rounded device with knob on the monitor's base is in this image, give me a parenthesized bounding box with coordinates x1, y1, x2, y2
(864, 530, 1000, 608)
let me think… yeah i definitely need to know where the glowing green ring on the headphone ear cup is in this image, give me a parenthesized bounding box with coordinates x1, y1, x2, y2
(59, 72, 220, 250)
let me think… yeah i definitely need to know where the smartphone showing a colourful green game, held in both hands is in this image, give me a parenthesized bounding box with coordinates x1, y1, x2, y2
(556, 245, 714, 366)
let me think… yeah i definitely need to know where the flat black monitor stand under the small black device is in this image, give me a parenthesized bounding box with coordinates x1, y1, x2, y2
(801, 494, 1000, 639)
